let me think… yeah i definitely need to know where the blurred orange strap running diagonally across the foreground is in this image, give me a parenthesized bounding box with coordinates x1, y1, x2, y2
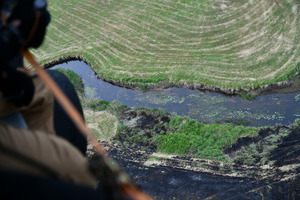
(22, 50, 151, 200)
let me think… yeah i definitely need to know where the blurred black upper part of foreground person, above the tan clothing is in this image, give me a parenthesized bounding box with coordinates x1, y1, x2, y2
(0, 0, 50, 106)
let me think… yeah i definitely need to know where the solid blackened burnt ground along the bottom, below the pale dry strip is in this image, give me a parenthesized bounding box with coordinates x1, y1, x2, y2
(110, 144, 300, 200)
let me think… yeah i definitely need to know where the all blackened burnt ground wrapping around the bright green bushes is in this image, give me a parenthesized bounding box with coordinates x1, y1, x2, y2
(86, 99, 300, 200)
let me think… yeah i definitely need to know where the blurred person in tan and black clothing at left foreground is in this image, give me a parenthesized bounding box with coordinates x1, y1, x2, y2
(0, 0, 111, 199)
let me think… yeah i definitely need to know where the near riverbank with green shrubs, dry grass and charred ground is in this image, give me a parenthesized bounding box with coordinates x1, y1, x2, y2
(55, 68, 300, 200)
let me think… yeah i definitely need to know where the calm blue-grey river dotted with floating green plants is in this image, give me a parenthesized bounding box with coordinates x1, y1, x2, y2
(52, 61, 300, 126)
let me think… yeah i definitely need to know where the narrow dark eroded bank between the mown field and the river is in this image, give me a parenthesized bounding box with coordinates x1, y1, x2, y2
(43, 56, 300, 98)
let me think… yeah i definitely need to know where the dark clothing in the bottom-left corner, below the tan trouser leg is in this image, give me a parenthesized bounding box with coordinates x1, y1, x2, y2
(0, 170, 109, 200)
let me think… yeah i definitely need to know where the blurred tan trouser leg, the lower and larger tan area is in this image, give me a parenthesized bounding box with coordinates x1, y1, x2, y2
(0, 122, 96, 187)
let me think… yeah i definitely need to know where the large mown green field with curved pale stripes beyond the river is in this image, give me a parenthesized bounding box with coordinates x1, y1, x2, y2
(34, 0, 300, 88)
